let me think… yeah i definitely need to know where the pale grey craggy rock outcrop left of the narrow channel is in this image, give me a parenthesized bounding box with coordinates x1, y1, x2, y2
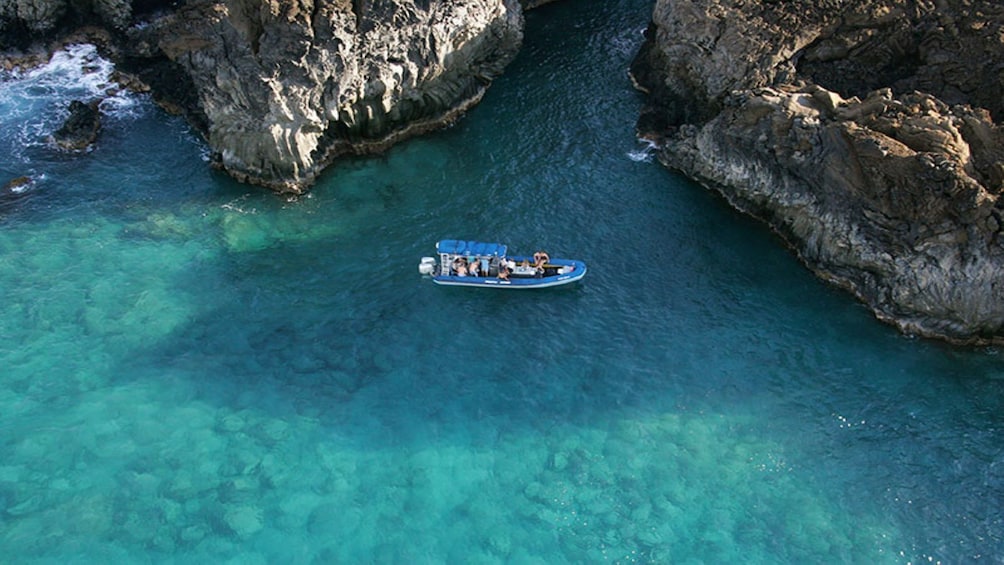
(118, 0, 523, 193)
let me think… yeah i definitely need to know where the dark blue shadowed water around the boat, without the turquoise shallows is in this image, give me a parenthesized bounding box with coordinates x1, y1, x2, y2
(0, 2, 1004, 554)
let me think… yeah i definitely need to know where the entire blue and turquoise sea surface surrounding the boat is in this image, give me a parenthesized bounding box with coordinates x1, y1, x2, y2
(0, 0, 1004, 564)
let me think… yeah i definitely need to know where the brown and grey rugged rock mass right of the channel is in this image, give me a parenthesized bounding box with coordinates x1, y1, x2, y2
(633, 0, 1004, 343)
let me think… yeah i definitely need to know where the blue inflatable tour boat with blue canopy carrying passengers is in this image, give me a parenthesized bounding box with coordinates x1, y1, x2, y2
(419, 240, 585, 288)
